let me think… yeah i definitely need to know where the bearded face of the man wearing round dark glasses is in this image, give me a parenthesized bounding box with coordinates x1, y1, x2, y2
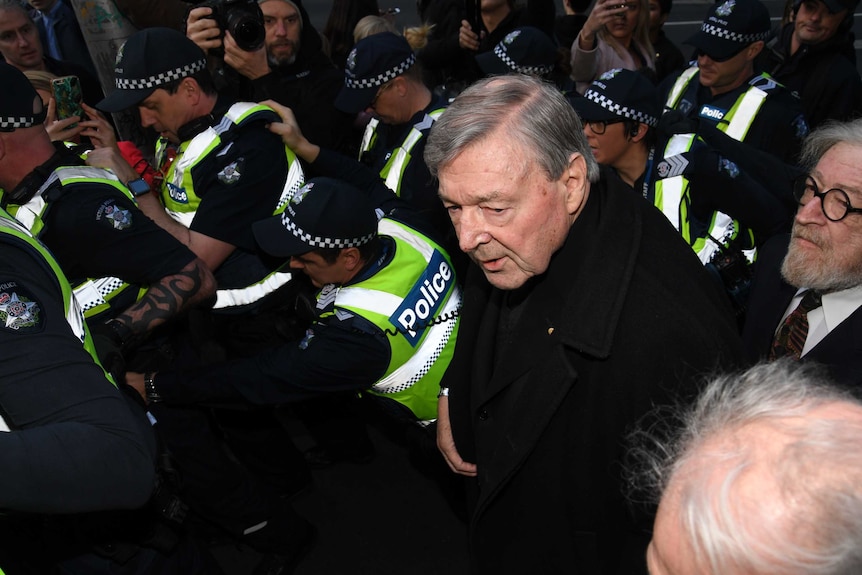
(781, 143, 862, 292)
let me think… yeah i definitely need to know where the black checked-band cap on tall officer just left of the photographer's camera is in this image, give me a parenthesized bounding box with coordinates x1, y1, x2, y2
(96, 28, 207, 112)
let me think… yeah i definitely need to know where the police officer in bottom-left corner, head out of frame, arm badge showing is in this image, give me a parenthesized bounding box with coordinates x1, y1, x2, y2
(0, 200, 226, 575)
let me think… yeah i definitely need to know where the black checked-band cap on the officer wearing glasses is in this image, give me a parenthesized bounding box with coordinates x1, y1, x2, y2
(572, 68, 661, 127)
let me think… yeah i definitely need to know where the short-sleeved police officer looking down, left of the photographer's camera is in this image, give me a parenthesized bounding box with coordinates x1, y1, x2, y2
(93, 28, 314, 572)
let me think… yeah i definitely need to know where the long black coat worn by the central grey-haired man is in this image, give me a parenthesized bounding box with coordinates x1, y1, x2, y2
(444, 178, 740, 575)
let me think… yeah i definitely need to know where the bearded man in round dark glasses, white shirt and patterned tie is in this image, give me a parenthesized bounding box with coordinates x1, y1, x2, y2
(743, 119, 862, 387)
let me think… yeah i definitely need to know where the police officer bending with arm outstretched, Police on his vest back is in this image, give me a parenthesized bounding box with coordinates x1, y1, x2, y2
(130, 178, 460, 426)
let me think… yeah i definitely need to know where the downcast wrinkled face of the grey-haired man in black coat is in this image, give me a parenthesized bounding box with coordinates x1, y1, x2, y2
(439, 129, 589, 290)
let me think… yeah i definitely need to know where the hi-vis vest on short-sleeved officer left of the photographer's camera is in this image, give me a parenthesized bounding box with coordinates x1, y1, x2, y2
(156, 102, 305, 309)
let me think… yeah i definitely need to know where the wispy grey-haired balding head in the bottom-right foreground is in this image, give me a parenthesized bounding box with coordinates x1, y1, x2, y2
(635, 360, 862, 575)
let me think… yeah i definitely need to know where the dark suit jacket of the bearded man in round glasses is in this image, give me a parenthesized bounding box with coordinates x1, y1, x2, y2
(742, 234, 862, 391)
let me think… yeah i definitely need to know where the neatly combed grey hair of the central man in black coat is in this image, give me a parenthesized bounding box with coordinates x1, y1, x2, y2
(425, 74, 599, 182)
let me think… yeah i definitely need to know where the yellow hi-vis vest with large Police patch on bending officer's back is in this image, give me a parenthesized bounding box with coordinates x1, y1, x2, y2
(326, 218, 461, 424)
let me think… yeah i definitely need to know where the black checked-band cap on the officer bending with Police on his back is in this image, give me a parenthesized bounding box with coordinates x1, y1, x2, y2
(253, 178, 377, 258)
